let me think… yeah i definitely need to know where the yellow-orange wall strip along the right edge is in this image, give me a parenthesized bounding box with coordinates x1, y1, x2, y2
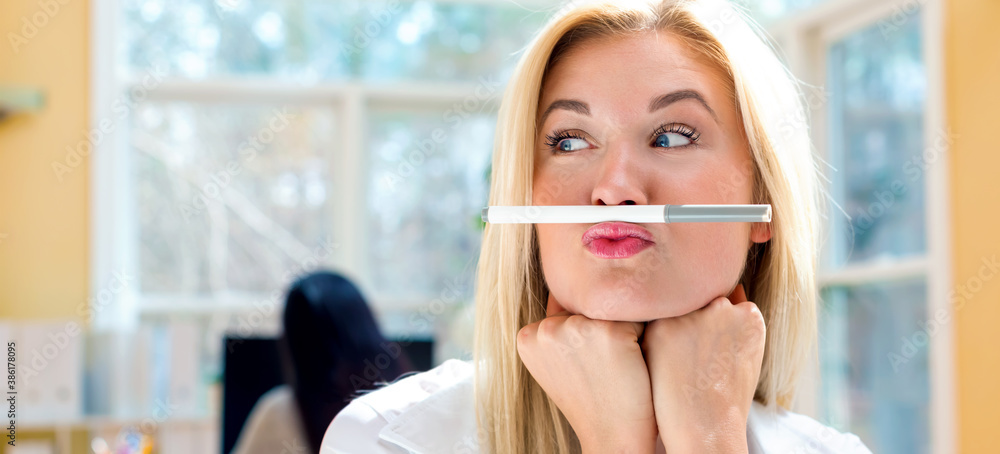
(945, 0, 1000, 453)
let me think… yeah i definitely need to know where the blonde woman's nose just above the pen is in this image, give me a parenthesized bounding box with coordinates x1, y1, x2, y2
(591, 144, 649, 205)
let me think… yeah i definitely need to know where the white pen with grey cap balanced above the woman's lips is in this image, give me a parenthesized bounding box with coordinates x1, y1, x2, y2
(483, 205, 771, 224)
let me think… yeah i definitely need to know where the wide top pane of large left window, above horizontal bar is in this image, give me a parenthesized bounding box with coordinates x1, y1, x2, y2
(122, 0, 550, 80)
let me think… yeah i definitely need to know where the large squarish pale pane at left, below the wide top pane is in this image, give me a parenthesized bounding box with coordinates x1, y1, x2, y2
(130, 102, 336, 295)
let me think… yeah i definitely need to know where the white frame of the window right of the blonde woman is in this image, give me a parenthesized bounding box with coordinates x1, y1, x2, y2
(766, 0, 958, 453)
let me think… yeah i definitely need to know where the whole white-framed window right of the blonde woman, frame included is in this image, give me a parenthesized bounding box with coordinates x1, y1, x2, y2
(750, 0, 954, 453)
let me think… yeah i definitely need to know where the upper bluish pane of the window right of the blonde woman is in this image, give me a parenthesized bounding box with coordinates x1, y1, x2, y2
(828, 12, 929, 267)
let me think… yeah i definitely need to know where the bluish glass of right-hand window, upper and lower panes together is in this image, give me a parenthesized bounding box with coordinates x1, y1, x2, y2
(821, 13, 930, 453)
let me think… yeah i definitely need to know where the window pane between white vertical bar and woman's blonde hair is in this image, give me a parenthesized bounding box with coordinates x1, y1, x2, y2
(368, 110, 496, 297)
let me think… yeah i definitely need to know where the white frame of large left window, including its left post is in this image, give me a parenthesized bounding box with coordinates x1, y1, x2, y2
(90, 0, 528, 336)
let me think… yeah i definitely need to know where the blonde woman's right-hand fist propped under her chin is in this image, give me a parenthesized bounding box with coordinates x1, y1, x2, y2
(642, 285, 765, 453)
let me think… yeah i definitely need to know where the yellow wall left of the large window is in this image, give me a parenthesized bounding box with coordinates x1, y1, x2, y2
(0, 0, 90, 318)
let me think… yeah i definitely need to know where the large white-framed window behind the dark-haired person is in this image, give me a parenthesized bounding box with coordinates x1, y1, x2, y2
(88, 0, 555, 424)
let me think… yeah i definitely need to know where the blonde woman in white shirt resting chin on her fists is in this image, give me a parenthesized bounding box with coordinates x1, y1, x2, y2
(323, 0, 869, 454)
